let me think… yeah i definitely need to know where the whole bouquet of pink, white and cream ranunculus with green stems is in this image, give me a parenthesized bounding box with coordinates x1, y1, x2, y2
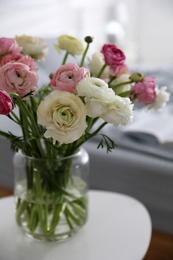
(0, 35, 169, 242)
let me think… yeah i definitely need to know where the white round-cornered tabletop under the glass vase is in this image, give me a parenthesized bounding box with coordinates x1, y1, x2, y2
(0, 191, 152, 260)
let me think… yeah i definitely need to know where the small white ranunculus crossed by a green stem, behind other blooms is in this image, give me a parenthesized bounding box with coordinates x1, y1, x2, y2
(111, 74, 131, 95)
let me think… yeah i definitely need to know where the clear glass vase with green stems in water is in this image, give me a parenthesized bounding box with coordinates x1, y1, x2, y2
(13, 148, 89, 241)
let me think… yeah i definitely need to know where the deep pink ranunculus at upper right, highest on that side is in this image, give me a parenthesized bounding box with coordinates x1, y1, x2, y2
(101, 44, 126, 66)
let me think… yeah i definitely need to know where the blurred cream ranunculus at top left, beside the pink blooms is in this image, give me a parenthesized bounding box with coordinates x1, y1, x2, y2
(15, 35, 48, 61)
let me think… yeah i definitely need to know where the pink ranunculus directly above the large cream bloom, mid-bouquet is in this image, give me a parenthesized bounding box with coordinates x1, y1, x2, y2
(51, 63, 90, 94)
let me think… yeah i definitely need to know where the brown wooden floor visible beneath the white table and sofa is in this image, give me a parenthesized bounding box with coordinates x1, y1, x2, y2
(0, 187, 173, 260)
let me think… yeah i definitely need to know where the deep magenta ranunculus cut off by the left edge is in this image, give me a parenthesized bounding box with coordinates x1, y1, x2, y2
(0, 89, 14, 115)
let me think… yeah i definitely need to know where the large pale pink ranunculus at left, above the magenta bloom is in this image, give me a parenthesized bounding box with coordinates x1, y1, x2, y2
(0, 62, 38, 97)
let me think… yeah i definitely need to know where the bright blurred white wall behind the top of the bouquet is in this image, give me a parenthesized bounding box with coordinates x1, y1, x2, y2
(0, 0, 173, 65)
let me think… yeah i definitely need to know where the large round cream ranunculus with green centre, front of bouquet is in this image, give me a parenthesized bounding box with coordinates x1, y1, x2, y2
(37, 90, 87, 144)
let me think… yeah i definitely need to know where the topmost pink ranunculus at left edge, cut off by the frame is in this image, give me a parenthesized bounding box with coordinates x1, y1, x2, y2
(0, 37, 22, 56)
